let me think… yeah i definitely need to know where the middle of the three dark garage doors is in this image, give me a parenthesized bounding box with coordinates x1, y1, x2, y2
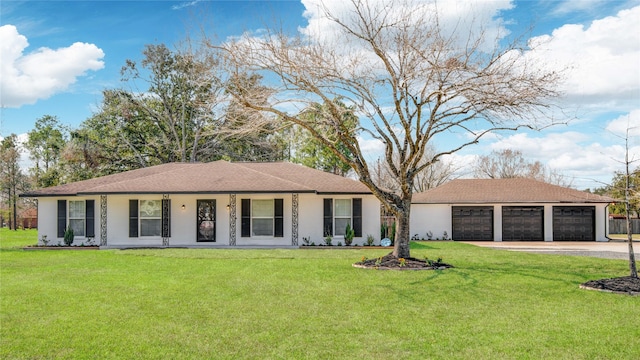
(502, 206, 544, 241)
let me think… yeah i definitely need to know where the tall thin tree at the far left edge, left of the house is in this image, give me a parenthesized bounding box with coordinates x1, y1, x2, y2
(0, 134, 27, 230)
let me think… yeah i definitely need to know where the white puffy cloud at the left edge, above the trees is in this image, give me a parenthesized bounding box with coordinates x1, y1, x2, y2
(0, 25, 104, 108)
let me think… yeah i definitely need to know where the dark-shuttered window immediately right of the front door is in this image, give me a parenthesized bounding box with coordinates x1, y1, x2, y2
(241, 199, 284, 237)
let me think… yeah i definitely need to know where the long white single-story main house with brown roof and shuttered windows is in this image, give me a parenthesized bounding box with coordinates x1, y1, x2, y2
(22, 161, 380, 248)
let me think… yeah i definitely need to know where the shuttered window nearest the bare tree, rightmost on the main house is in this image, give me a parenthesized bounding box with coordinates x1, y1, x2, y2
(323, 198, 362, 237)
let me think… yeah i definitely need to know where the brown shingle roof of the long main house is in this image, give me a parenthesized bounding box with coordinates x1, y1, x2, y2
(23, 160, 371, 197)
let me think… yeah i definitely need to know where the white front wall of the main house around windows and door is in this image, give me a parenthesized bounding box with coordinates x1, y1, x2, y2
(38, 193, 380, 247)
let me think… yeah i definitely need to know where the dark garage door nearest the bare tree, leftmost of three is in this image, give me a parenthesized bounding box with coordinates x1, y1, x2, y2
(451, 206, 493, 241)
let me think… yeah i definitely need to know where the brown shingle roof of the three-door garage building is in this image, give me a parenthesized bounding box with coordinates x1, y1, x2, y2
(412, 178, 615, 204)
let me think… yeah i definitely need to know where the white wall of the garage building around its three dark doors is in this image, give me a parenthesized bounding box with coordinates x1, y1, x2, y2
(410, 203, 609, 241)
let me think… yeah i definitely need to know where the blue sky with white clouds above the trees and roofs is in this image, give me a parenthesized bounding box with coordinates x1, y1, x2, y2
(0, 0, 640, 189)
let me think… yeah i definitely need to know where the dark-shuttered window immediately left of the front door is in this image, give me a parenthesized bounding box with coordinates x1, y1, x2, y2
(129, 199, 171, 237)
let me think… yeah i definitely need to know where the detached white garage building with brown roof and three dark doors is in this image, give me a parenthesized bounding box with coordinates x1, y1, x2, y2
(410, 178, 615, 241)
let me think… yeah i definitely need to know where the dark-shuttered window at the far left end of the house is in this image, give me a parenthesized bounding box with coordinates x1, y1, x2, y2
(58, 200, 95, 238)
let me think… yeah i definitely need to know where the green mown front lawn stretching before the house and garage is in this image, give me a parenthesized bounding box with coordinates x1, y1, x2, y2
(0, 229, 640, 359)
